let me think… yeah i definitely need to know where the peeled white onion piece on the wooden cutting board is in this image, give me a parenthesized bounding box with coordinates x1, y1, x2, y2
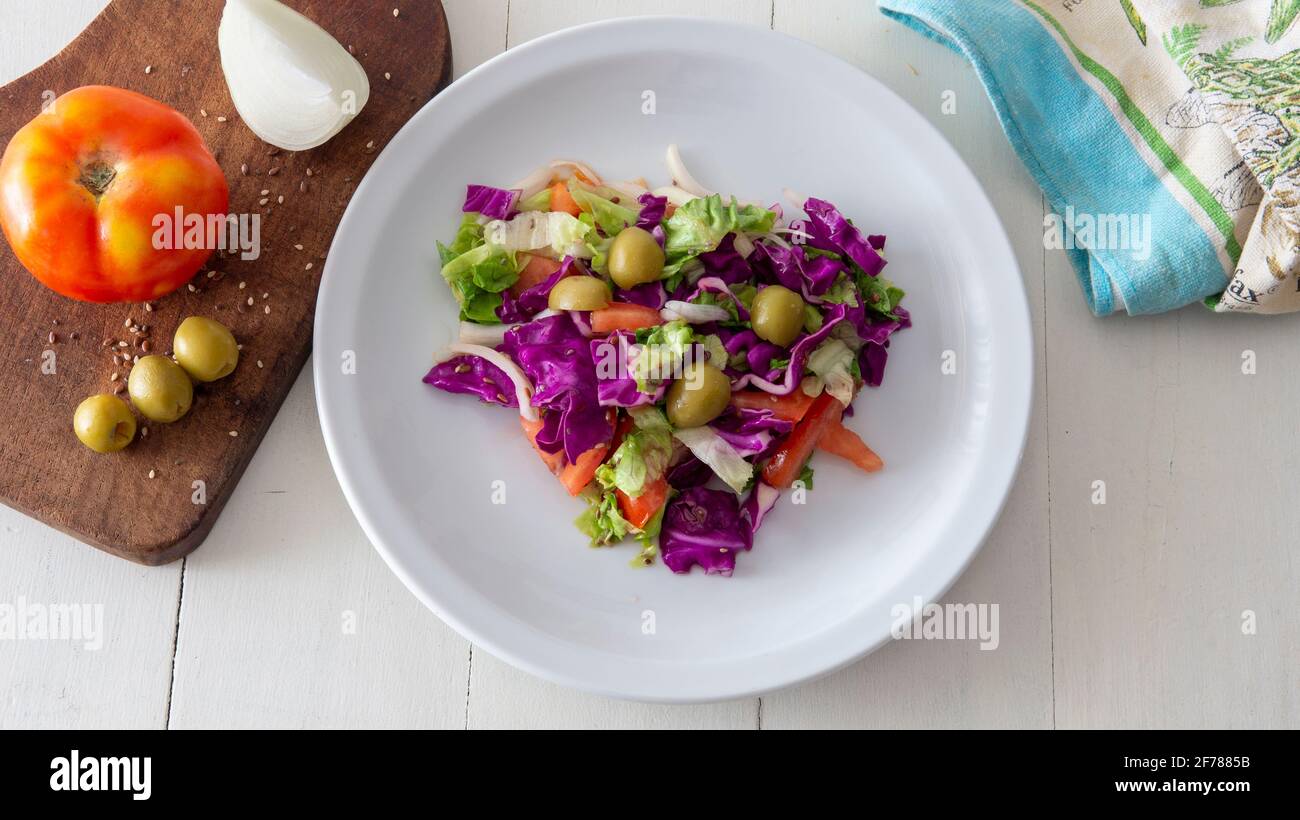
(217, 0, 371, 151)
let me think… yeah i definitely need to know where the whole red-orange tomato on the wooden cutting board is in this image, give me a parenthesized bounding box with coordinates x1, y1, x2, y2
(0, 86, 230, 301)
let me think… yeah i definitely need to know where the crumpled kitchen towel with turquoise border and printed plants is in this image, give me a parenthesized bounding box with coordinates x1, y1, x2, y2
(879, 0, 1300, 316)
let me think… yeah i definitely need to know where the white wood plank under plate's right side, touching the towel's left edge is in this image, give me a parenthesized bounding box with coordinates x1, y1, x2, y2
(762, 0, 1052, 728)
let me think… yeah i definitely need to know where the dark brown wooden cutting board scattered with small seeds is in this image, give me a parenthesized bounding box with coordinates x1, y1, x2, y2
(0, 0, 451, 564)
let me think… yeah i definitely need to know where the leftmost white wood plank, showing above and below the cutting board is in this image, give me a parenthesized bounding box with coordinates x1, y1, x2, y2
(0, 0, 181, 729)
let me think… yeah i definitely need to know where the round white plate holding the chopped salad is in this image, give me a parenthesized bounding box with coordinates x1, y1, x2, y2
(315, 18, 1032, 702)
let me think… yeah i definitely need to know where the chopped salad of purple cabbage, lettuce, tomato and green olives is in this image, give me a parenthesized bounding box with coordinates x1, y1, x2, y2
(424, 146, 911, 576)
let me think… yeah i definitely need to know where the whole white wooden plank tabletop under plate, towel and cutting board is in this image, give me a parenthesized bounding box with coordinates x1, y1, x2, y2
(0, 0, 1300, 728)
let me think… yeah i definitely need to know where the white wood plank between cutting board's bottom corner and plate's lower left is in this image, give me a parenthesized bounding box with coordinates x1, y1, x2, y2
(170, 364, 469, 728)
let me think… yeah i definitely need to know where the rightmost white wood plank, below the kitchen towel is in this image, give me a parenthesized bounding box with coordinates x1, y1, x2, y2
(1048, 261, 1300, 728)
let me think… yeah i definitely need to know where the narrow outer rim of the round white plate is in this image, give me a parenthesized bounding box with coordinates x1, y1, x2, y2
(312, 14, 1037, 703)
